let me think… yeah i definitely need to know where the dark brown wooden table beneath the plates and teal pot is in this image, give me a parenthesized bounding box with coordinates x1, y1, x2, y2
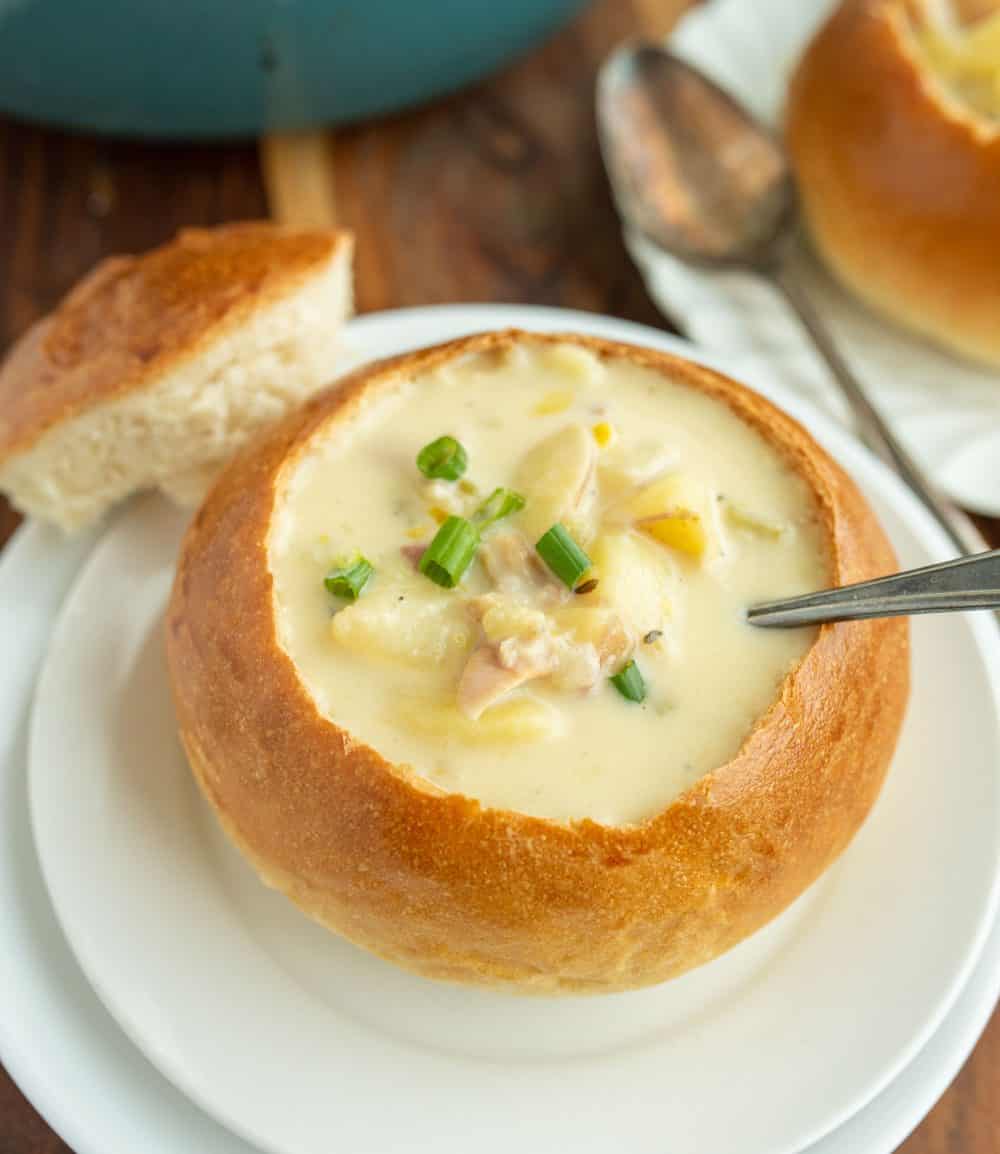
(0, 0, 1000, 1154)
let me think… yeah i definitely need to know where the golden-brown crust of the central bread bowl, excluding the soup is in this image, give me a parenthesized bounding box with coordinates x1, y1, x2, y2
(166, 331, 909, 994)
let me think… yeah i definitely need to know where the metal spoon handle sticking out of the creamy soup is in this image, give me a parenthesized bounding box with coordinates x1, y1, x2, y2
(746, 549, 1000, 628)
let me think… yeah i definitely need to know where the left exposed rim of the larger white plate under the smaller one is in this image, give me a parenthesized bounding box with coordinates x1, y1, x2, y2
(0, 524, 253, 1154)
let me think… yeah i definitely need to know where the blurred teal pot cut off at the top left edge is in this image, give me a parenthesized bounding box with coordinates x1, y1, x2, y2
(0, 0, 585, 137)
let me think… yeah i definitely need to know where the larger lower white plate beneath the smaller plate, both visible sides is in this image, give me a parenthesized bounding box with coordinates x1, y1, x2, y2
(0, 493, 1000, 1154)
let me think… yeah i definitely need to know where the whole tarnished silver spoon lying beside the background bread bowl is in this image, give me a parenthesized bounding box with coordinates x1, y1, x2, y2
(597, 44, 986, 553)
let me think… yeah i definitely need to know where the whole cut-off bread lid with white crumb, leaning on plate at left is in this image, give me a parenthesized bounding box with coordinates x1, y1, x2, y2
(0, 222, 353, 530)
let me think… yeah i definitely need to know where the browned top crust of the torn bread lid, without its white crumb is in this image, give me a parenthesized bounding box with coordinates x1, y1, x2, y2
(0, 222, 348, 460)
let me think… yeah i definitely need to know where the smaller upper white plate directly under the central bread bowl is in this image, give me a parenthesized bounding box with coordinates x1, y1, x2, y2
(11, 309, 997, 1154)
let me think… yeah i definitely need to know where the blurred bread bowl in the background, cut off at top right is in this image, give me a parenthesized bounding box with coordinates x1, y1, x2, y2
(787, 0, 1000, 366)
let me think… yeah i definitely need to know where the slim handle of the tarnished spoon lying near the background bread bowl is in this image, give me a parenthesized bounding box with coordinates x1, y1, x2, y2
(770, 265, 986, 563)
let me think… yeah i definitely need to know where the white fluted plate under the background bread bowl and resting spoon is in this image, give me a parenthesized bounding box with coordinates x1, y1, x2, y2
(631, 0, 1000, 516)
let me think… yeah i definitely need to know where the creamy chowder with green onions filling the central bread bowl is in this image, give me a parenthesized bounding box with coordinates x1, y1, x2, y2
(269, 344, 828, 825)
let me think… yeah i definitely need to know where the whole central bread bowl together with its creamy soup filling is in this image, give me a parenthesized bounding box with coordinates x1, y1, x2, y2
(166, 331, 908, 994)
